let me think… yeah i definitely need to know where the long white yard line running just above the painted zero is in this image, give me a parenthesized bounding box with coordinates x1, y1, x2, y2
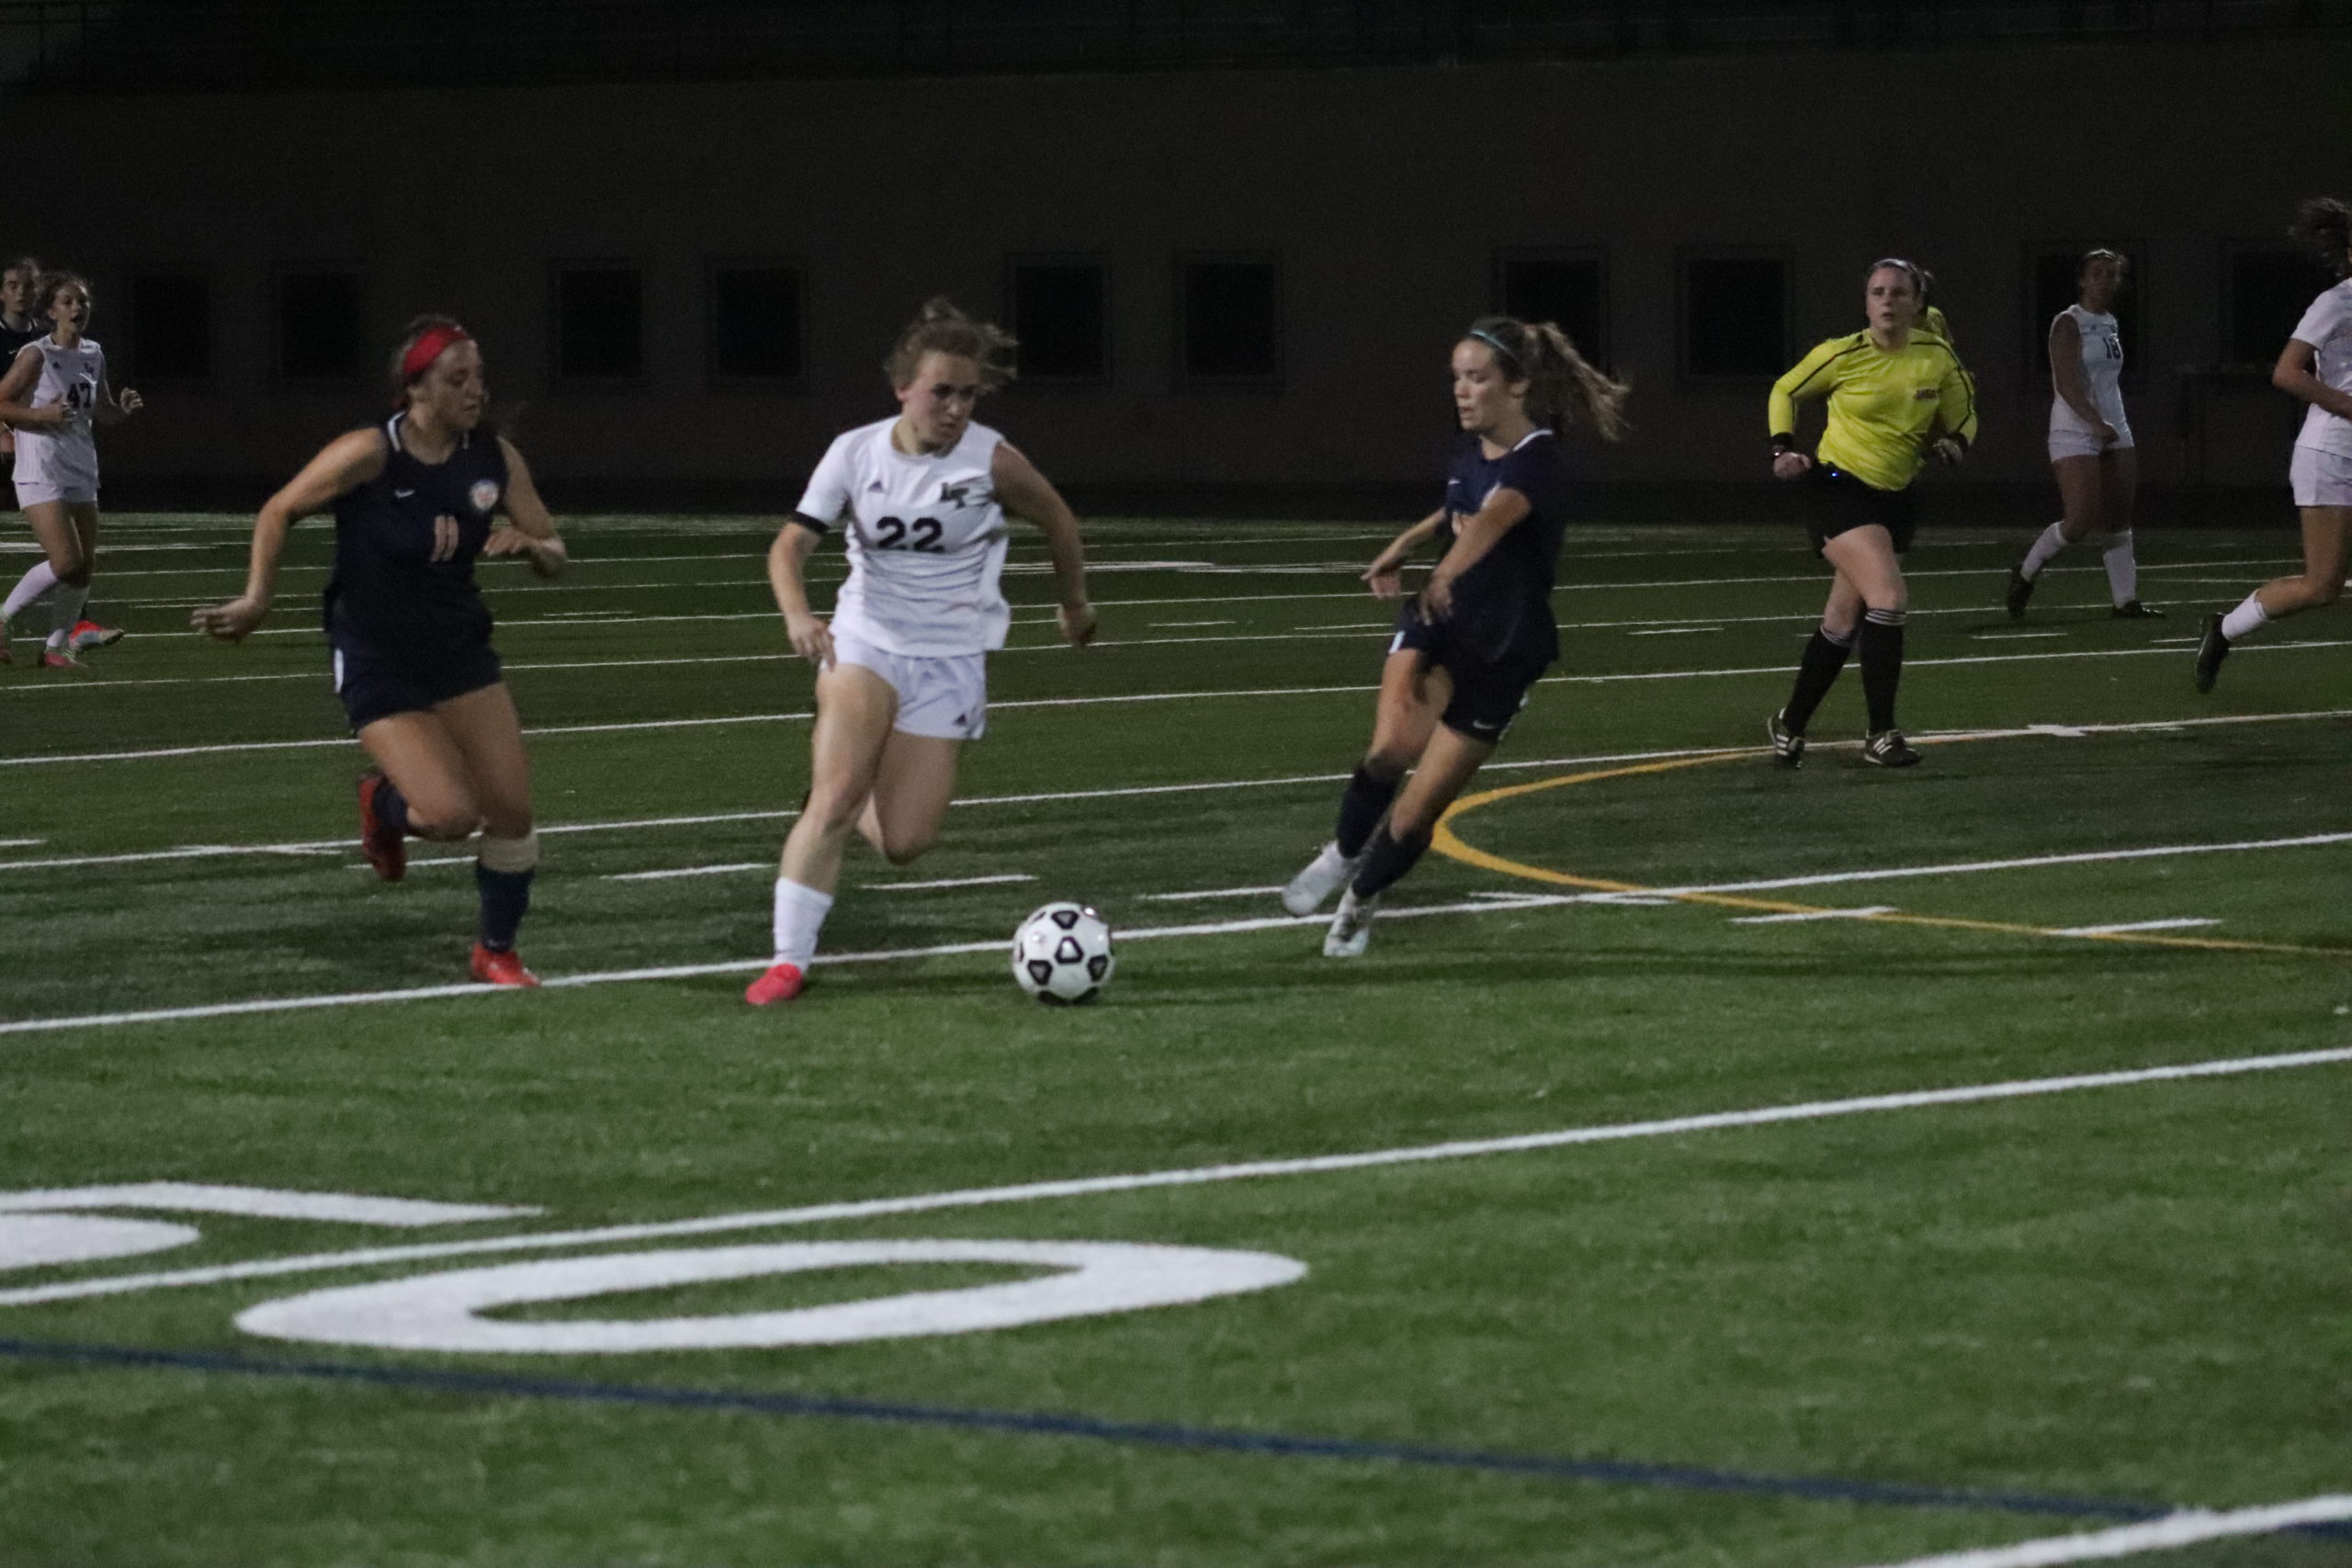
(0, 1048, 2352, 1316)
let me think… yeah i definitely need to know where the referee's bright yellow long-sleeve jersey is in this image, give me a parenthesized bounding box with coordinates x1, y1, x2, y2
(1771, 332, 1975, 489)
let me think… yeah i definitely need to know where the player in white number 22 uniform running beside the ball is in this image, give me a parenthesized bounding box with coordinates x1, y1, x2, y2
(743, 299, 1093, 1006)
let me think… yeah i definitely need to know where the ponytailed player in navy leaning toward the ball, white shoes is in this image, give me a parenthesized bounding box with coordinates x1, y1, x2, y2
(1282, 315, 1628, 959)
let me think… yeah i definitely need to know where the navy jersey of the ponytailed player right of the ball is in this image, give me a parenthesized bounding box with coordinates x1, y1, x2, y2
(1446, 430, 1569, 663)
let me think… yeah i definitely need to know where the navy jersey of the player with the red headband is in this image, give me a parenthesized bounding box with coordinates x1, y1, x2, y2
(324, 413, 505, 660)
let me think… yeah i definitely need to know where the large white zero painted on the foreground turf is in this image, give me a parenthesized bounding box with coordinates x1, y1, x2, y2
(238, 1241, 1307, 1357)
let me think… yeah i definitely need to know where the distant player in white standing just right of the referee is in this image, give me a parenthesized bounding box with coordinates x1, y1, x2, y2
(2008, 249, 2164, 621)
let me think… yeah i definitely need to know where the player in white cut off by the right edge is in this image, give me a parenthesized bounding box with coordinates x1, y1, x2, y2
(2197, 197, 2352, 691)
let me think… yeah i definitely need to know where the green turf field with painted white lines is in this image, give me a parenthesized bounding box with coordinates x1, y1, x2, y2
(0, 508, 2352, 1568)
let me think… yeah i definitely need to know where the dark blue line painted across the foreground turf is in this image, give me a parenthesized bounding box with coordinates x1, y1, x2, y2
(0, 1337, 2176, 1521)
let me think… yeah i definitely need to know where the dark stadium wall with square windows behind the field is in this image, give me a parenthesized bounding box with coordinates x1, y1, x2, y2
(0, 40, 2352, 510)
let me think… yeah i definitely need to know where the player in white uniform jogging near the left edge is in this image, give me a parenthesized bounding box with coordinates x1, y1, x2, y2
(0, 273, 141, 668)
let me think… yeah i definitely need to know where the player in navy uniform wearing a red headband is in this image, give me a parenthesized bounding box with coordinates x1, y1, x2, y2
(193, 315, 564, 985)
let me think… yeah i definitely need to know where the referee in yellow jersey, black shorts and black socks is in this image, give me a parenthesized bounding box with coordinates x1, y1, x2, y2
(1764, 259, 1975, 769)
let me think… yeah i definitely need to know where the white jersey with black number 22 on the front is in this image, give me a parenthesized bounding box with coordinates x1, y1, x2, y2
(793, 419, 1012, 659)
